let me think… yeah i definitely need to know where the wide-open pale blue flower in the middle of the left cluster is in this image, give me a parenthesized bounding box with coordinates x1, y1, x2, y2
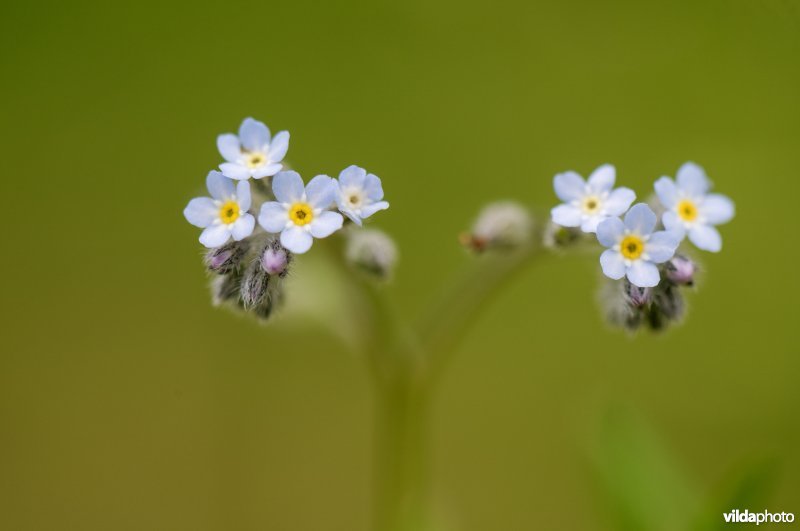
(258, 171, 344, 254)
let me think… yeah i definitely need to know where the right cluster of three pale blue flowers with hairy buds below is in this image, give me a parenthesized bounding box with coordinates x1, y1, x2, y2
(551, 162, 734, 329)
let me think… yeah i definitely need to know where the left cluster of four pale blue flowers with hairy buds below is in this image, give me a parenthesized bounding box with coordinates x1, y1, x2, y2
(183, 118, 389, 317)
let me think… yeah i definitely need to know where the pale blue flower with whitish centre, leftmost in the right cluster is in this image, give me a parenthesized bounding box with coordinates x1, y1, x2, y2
(551, 164, 636, 232)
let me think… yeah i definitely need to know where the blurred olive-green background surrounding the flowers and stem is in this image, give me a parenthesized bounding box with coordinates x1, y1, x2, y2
(0, 0, 800, 531)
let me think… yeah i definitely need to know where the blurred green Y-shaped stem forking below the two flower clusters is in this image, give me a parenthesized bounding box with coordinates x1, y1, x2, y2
(356, 235, 538, 531)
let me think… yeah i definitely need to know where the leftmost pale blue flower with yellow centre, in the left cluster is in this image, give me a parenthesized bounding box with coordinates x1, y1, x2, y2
(183, 171, 256, 248)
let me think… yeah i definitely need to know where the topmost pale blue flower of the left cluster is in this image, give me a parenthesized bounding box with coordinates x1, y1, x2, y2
(217, 118, 289, 180)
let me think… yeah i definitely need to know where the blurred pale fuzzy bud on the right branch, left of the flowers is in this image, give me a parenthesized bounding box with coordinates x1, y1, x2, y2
(460, 202, 533, 252)
